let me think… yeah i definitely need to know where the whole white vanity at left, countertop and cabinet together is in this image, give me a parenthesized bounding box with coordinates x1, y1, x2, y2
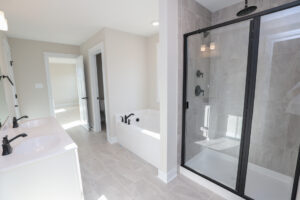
(0, 118, 83, 200)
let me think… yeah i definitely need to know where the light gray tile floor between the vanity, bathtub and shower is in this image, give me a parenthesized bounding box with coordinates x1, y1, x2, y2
(59, 107, 224, 200)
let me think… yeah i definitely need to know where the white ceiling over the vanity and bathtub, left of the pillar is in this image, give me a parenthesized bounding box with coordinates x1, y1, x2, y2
(0, 0, 159, 45)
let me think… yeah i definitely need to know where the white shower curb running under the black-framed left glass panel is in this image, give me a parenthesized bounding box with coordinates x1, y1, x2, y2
(180, 167, 244, 200)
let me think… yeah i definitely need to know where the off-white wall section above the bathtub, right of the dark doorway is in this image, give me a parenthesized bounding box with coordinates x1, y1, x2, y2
(105, 29, 148, 135)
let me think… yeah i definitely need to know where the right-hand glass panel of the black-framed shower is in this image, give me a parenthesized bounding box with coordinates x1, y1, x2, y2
(245, 7, 300, 200)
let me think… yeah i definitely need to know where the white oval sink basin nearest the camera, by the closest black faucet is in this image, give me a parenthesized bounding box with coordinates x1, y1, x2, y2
(13, 135, 60, 155)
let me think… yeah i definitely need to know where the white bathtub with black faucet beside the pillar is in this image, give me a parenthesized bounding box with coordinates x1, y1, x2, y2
(116, 110, 160, 168)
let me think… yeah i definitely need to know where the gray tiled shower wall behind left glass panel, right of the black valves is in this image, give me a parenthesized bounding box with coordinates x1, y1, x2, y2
(208, 22, 249, 150)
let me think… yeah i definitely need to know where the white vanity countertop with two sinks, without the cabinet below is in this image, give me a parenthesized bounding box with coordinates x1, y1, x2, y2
(0, 117, 77, 173)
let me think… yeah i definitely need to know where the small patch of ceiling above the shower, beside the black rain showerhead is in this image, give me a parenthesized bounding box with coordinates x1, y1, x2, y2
(196, 0, 244, 12)
